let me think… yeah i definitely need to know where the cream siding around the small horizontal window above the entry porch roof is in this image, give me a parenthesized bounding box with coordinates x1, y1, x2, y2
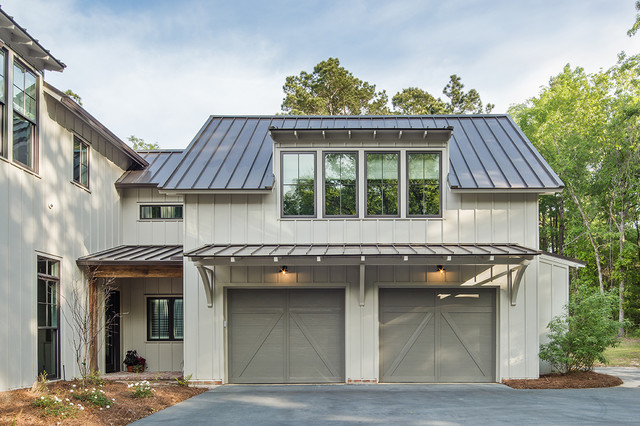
(121, 188, 183, 245)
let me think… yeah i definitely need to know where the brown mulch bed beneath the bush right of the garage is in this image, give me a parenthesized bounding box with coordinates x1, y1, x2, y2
(502, 371, 622, 389)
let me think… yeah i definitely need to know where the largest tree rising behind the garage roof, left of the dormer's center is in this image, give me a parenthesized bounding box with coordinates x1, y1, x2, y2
(282, 58, 389, 115)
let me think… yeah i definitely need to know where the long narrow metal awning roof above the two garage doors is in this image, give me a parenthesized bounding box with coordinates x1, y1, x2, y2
(184, 243, 540, 263)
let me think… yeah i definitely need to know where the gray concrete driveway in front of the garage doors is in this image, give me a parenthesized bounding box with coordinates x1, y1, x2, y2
(135, 368, 640, 425)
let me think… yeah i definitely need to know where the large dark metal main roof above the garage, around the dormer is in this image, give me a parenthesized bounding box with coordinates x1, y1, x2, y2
(159, 114, 564, 192)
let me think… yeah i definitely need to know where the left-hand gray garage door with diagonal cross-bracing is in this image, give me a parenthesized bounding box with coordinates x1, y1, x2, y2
(227, 289, 344, 383)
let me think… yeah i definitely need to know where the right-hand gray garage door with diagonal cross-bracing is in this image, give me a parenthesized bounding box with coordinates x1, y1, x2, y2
(379, 289, 496, 382)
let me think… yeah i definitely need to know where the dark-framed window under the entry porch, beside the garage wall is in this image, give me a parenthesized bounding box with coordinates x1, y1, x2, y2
(147, 297, 184, 340)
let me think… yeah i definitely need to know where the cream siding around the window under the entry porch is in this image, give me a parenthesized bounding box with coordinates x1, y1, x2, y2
(114, 278, 183, 372)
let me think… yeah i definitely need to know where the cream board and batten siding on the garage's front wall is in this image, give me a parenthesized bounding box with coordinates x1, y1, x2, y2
(184, 186, 539, 381)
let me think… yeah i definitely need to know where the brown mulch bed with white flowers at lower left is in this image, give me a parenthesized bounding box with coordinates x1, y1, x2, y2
(0, 381, 208, 425)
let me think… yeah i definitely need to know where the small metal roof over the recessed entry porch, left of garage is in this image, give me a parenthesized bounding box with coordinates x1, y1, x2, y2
(76, 245, 182, 266)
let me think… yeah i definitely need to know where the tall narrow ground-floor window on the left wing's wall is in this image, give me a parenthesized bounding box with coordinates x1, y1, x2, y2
(38, 257, 60, 378)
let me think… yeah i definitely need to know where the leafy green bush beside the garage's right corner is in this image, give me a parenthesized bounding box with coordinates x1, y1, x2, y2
(540, 293, 620, 373)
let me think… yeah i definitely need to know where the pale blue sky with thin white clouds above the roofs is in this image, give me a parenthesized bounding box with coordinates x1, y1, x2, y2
(2, 0, 640, 148)
